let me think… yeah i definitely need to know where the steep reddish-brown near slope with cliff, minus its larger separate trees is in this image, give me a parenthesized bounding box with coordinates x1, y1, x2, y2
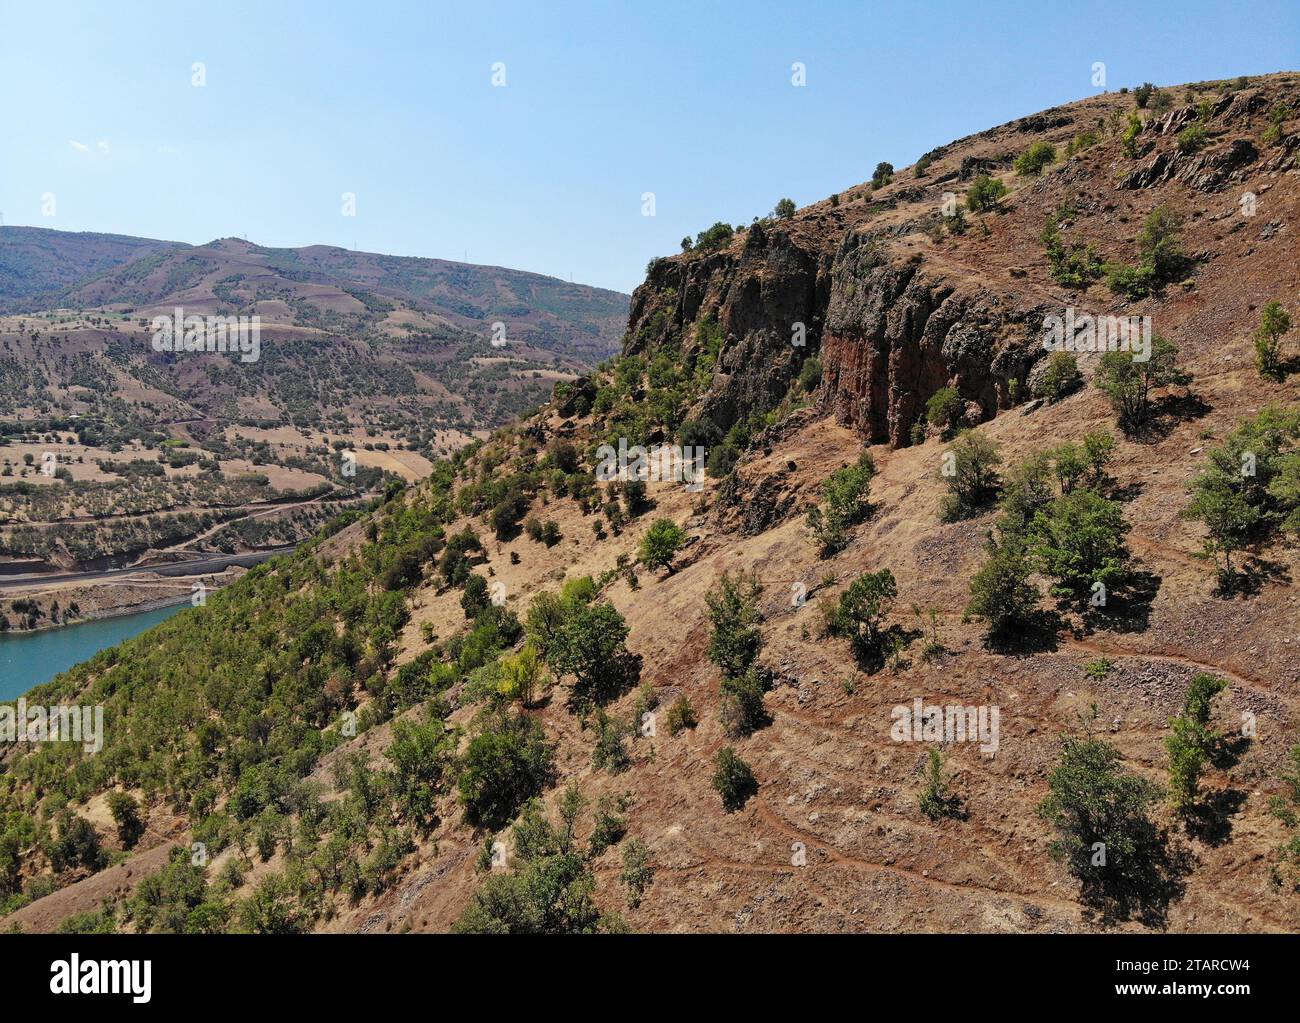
(0, 74, 1300, 932)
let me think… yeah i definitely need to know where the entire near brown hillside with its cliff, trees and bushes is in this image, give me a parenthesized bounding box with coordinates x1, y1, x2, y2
(0, 73, 1300, 933)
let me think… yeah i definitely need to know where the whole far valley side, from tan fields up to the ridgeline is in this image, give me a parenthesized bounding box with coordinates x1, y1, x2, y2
(0, 227, 627, 610)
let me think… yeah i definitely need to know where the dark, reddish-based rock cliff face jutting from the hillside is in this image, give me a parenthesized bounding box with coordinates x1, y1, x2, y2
(624, 209, 1037, 446)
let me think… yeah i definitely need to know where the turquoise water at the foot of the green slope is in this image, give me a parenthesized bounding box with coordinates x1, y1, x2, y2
(0, 602, 190, 701)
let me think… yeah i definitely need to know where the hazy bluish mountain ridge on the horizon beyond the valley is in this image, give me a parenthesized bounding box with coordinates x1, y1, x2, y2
(0, 227, 628, 365)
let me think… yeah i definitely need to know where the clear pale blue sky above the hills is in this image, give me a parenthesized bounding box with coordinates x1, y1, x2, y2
(0, 0, 1300, 291)
